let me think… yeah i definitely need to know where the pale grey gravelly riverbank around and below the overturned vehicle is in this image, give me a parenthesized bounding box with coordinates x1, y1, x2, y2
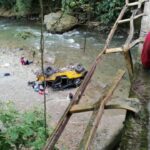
(0, 48, 126, 150)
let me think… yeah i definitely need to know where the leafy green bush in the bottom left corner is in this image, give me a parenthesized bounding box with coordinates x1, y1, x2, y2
(0, 102, 50, 150)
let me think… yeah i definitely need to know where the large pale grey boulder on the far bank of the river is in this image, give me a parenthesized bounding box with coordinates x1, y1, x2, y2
(44, 12, 78, 33)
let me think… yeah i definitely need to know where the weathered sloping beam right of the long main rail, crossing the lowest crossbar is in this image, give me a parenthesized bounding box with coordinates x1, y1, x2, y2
(79, 70, 125, 150)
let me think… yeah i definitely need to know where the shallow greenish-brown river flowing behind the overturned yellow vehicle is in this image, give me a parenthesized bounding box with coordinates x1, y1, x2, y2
(0, 19, 129, 97)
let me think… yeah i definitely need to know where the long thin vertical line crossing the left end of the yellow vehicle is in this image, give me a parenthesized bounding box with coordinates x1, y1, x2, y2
(39, 0, 47, 139)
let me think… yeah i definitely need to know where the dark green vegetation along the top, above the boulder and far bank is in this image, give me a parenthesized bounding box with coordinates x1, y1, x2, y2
(0, 0, 124, 24)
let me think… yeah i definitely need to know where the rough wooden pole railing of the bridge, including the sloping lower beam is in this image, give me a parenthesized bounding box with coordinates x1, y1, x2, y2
(43, 0, 146, 150)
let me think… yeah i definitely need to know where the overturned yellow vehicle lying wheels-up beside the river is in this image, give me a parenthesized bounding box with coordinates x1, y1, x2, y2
(37, 64, 87, 89)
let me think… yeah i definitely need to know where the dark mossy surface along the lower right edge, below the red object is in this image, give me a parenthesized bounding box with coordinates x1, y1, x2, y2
(120, 64, 150, 150)
